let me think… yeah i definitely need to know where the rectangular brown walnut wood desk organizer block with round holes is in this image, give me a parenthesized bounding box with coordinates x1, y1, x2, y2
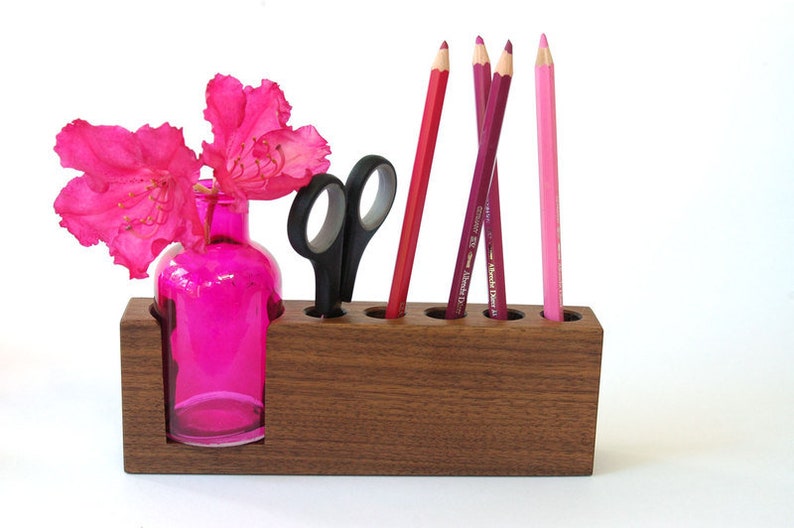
(121, 298, 603, 475)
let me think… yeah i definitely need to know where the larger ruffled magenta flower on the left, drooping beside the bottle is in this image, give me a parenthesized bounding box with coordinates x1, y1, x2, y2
(55, 119, 204, 278)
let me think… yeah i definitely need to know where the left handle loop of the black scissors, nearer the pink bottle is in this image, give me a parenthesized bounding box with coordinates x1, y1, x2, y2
(287, 174, 347, 317)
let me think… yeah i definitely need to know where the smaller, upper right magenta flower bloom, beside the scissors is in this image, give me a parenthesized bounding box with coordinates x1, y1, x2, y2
(201, 75, 331, 201)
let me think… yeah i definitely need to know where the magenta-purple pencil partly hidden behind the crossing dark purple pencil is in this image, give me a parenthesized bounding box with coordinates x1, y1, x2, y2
(472, 37, 507, 319)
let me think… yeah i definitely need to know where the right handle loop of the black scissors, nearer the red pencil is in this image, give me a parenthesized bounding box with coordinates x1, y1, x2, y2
(340, 154, 397, 302)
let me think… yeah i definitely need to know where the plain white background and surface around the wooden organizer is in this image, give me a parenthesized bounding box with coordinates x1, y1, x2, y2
(0, 0, 794, 527)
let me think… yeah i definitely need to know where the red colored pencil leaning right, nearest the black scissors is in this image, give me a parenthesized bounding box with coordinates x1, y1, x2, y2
(385, 41, 449, 319)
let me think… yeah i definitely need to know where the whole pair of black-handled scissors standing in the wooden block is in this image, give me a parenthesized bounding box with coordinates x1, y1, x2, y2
(287, 155, 397, 317)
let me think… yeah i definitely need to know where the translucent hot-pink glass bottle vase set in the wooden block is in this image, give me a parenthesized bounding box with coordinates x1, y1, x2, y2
(155, 190, 283, 447)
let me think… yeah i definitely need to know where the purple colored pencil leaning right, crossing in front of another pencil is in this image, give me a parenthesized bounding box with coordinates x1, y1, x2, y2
(445, 40, 513, 319)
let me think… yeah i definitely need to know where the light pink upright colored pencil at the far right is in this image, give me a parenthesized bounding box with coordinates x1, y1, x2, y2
(535, 34, 564, 321)
